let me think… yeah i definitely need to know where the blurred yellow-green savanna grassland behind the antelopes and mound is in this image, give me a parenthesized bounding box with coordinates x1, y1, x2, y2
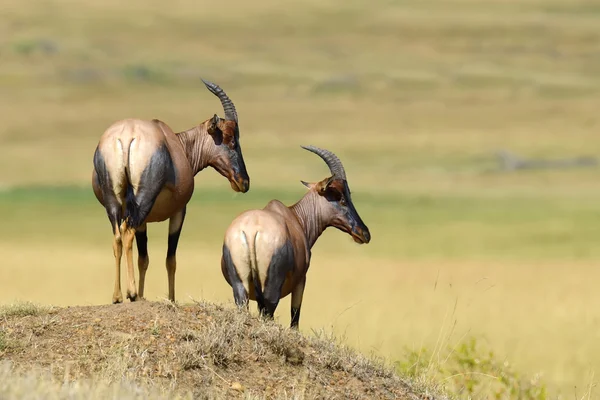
(0, 0, 600, 398)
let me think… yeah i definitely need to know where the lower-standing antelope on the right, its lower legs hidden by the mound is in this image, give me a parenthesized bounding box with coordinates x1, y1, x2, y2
(221, 146, 371, 329)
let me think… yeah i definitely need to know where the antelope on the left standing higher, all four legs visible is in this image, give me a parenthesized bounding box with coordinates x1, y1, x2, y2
(92, 80, 250, 303)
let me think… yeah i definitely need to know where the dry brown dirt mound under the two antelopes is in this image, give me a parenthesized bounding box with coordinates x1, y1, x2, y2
(0, 301, 440, 399)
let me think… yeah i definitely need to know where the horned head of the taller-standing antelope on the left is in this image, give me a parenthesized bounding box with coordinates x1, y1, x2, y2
(202, 79, 250, 193)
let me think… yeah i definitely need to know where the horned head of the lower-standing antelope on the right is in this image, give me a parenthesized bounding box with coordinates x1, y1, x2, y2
(301, 146, 371, 244)
